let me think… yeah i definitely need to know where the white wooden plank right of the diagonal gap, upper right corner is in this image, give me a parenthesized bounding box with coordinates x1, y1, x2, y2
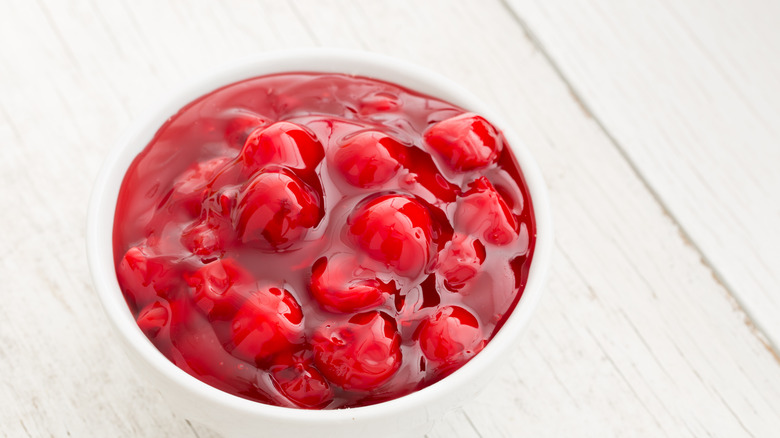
(507, 0, 780, 351)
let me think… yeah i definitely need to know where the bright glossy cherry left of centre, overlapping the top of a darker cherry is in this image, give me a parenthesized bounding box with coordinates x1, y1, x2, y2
(240, 121, 325, 173)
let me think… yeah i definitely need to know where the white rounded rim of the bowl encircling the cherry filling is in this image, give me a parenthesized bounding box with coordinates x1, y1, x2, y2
(86, 48, 553, 423)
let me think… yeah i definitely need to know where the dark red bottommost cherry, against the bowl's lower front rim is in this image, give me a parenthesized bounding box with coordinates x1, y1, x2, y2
(269, 355, 334, 409)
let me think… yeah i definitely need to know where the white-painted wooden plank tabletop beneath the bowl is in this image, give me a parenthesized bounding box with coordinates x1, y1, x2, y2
(0, 0, 780, 438)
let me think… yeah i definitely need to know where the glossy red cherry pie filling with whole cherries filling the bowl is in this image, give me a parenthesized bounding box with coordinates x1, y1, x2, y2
(113, 73, 535, 409)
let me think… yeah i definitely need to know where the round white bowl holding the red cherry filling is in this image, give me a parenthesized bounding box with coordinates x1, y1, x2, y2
(87, 49, 552, 438)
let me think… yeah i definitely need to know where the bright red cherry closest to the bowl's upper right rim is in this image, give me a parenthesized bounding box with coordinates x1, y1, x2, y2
(423, 113, 502, 171)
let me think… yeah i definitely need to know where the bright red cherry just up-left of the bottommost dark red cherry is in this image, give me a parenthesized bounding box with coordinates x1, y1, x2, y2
(225, 287, 303, 364)
